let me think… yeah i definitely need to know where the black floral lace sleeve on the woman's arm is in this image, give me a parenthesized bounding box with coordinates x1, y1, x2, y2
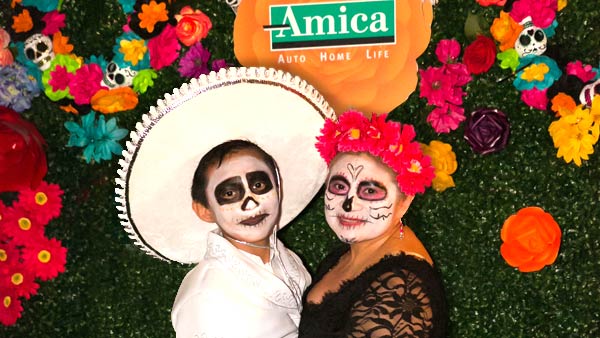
(348, 269, 433, 338)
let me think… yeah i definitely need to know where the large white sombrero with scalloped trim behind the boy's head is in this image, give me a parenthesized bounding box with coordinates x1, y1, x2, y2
(115, 68, 335, 263)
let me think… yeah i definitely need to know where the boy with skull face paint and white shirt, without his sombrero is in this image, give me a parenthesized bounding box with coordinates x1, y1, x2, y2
(172, 140, 310, 338)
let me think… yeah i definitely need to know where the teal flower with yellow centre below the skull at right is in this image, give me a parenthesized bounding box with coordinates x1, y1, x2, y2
(513, 55, 562, 91)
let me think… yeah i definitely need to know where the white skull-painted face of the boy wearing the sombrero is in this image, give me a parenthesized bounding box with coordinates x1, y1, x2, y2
(206, 152, 279, 243)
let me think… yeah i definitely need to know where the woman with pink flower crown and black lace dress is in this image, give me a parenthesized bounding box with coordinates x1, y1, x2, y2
(300, 111, 447, 338)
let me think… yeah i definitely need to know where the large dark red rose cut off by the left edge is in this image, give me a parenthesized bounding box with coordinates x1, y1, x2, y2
(0, 106, 48, 192)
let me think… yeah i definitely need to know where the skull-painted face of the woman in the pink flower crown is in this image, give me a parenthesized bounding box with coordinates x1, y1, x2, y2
(325, 153, 402, 243)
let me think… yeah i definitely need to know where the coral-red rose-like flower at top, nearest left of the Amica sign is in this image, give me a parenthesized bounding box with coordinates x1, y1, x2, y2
(175, 6, 212, 47)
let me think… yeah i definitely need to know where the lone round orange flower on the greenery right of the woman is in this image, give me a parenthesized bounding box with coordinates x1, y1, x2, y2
(500, 207, 561, 272)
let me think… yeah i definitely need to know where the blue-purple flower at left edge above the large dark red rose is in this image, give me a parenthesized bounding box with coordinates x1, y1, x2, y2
(0, 63, 40, 112)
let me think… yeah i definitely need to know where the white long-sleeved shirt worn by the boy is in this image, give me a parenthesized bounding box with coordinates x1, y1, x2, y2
(171, 230, 311, 338)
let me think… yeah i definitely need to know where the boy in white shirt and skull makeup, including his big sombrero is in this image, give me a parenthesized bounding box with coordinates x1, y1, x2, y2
(117, 67, 335, 338)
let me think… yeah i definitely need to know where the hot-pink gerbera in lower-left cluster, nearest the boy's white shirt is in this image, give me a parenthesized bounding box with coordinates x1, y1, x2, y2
(23, 238, 67, 281)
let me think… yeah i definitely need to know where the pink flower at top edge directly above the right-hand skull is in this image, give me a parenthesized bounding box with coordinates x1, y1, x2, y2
(510, 0, 558, 29)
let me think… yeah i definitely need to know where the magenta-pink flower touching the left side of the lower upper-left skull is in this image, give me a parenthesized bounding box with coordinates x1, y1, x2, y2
(69, 63, 108, 105)
